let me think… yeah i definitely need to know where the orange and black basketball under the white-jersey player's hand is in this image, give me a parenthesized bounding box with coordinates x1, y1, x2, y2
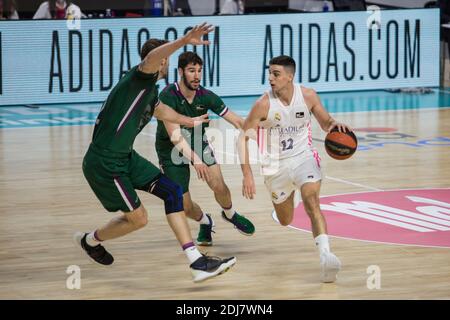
(325, 128, 358, 160)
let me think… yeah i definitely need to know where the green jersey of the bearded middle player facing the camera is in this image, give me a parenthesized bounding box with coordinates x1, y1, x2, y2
(155, 83, 228, 164)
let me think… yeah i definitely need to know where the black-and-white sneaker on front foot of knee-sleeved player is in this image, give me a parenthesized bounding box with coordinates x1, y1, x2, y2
(190, 255, 236, 282)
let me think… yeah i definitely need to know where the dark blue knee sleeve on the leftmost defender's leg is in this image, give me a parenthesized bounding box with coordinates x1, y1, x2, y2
(148, 175, 183, 214)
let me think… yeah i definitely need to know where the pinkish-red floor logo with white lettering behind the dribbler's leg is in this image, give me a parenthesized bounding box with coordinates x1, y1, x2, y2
(291, 188, 450, 248)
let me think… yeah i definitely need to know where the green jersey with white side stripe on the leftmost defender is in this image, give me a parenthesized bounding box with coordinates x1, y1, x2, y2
(92, 66, 159, 153)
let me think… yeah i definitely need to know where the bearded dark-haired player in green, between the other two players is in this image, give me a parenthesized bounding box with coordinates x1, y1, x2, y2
(155, 51, 255, 246)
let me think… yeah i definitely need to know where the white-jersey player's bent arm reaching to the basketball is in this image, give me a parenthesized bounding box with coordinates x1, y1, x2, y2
(302, 87, 352, 132)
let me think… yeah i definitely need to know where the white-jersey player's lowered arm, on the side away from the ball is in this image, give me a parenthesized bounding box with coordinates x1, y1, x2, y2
(238, 95, 269, 199)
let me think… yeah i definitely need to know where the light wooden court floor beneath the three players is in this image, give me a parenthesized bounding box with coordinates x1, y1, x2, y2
(0, 108, 450, 300)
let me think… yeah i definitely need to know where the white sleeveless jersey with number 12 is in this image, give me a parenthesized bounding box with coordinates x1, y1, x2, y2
(258, 84, 319, 174)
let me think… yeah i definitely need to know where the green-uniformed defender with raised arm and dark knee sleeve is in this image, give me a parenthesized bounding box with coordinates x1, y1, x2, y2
(74, 23, 236, 282)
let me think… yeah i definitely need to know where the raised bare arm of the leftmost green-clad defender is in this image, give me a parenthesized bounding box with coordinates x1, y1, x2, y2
(139, 22, 214, 73)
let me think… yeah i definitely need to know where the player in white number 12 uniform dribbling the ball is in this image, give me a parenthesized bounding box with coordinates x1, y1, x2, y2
(238, 56, 351, 282)
